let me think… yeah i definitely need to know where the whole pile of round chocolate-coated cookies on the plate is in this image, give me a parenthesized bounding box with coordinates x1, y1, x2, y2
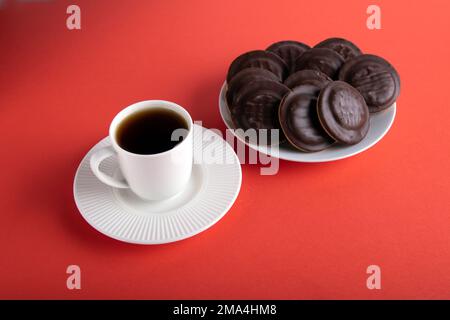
(226, 38, 400, 152)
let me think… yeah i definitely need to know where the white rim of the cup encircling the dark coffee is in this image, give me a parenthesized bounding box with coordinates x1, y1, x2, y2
(109, 100, 194, 158)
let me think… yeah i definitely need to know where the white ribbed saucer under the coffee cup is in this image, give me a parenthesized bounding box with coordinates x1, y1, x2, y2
(73, 125, 242, 244)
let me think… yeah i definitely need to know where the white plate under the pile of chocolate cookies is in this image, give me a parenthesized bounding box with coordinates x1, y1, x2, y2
(219, 83, 397, 162)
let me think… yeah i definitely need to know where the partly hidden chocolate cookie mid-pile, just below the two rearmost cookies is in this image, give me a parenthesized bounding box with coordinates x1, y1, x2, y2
(295, 48, 344, 79)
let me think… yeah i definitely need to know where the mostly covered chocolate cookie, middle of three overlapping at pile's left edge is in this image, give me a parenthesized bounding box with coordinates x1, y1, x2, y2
(226, 68, 278, 106)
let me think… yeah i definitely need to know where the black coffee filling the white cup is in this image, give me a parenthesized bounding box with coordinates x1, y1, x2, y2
(116, 108, 188, 154)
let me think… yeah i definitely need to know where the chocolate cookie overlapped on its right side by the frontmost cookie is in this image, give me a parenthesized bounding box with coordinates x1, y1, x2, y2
(278, 84, 335, 152)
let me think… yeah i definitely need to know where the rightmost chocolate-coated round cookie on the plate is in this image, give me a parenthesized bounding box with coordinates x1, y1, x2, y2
(339, 54, 400, 113)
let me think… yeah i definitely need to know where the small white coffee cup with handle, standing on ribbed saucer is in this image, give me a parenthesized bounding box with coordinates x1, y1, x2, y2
(90, 100, 193, 200)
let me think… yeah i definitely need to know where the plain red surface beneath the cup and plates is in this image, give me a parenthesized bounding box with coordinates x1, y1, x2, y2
(0, 0, 450, 299)
